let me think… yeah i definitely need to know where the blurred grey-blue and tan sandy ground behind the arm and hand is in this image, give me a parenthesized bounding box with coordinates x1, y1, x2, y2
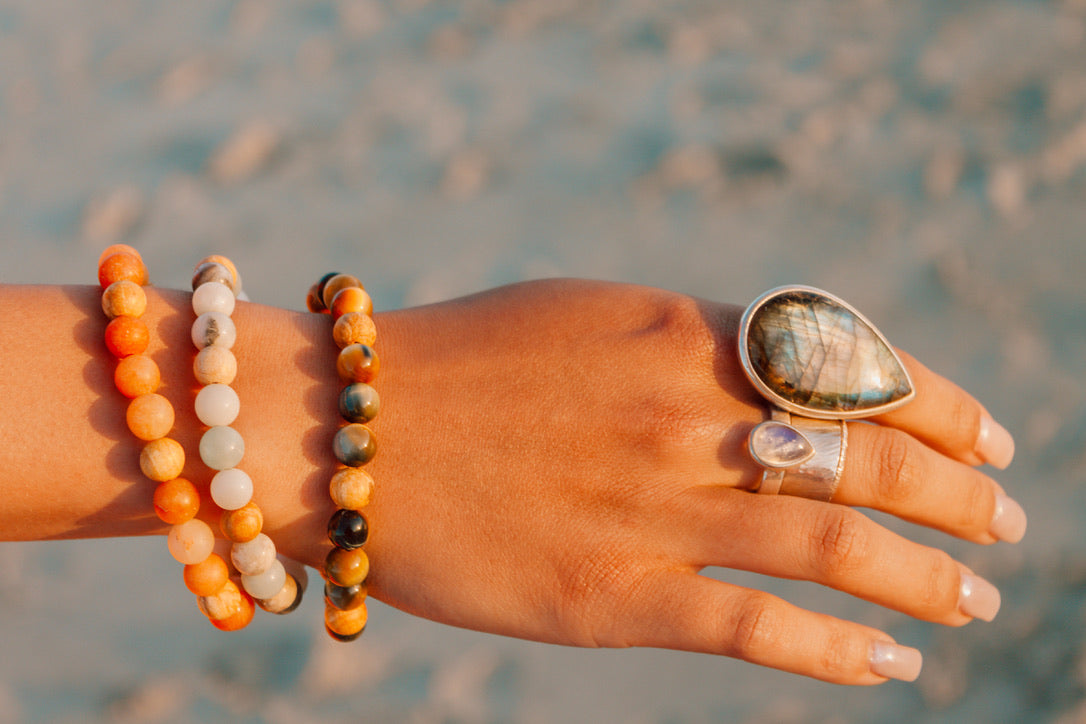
(0, 0, 1086, 723)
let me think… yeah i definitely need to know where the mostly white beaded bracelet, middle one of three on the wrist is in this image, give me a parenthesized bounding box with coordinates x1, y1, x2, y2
(192, 255, 304, 621)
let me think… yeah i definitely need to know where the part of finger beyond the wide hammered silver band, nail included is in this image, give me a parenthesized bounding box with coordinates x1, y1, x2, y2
(833, 423, 1026, 543)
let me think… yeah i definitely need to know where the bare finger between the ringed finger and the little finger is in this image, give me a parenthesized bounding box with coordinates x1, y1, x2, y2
(689, 491, 1000, 626)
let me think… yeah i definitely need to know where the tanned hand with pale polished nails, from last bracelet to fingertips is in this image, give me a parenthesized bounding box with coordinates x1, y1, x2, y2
(307, 281, 1025, 684)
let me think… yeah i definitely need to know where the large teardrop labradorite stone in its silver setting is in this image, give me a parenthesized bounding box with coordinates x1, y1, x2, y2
(746, 290, 912, 417)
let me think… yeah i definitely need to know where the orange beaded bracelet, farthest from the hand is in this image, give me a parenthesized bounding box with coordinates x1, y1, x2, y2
(98, 244, 229, 627)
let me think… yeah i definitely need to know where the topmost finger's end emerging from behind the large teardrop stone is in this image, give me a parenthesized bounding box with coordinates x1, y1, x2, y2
(874, 351, 1014, 469)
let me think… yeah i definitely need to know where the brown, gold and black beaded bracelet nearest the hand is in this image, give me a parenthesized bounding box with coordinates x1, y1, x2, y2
(305, 272, 380, 642)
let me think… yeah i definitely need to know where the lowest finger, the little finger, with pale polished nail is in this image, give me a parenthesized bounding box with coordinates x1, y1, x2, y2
(627, 571, 921, 685)
